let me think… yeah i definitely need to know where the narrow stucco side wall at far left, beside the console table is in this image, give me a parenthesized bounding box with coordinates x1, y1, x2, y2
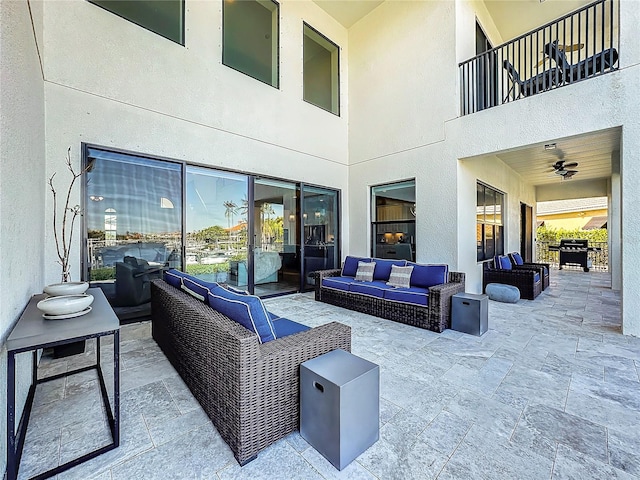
(0, 0, 46, 476)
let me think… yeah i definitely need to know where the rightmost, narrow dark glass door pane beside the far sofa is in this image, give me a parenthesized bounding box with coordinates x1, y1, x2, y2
(302, 185, 340, 289)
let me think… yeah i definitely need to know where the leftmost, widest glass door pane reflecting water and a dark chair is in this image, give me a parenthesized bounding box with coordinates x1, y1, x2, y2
(83, 148, 182, 320)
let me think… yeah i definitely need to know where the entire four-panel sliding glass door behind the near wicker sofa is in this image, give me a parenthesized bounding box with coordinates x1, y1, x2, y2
(83, 146, 340, 319)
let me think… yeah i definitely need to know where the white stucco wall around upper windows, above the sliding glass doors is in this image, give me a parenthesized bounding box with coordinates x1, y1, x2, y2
(44, 0, 349, 281)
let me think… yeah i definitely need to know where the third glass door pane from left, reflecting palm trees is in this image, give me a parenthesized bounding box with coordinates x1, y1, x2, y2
(252, 178, 300, 296)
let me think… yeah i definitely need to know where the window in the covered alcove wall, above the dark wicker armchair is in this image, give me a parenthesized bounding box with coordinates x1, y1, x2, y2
(476, 182, 504, 262)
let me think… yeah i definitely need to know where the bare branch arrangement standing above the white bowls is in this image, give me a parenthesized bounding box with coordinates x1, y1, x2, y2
(49, 147, 89, 282)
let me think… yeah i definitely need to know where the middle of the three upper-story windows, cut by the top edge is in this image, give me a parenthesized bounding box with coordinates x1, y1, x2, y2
(222, 0, 280, 88)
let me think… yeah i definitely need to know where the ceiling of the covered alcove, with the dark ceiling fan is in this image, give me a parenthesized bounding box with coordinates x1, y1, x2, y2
(496, 128, 621, 185)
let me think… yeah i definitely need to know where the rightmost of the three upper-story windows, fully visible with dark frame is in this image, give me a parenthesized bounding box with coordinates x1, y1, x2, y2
(304, 23, 340, 115)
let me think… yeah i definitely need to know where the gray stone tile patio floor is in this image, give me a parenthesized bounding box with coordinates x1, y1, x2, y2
(15, 270, 640, 480)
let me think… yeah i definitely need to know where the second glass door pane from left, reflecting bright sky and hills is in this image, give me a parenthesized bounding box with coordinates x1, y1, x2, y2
(185, 166, 249, 289)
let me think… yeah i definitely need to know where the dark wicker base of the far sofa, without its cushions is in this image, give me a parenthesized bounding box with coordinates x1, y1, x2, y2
(315, 270, 465, 333)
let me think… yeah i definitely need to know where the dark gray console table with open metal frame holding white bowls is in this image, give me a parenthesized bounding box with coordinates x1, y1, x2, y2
(7, 288, 120, 480)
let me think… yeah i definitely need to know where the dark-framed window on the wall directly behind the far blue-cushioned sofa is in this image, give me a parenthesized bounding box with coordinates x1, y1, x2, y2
(371, 180, 416, 261)
